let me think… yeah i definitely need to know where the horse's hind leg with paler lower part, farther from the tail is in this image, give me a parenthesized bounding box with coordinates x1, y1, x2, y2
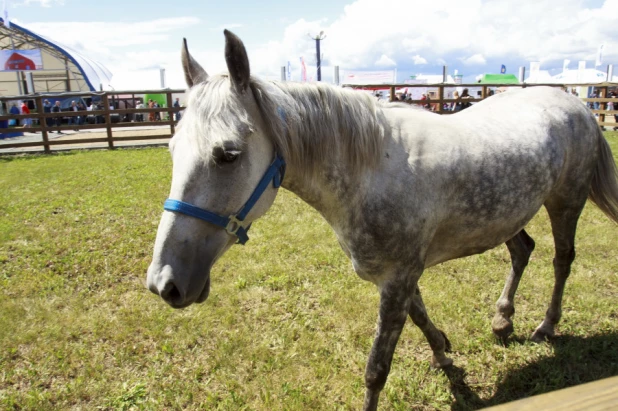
(491, 230, 534, 342)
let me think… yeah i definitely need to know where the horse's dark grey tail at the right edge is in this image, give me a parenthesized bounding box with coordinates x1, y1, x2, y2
(588, 128, 618, 223)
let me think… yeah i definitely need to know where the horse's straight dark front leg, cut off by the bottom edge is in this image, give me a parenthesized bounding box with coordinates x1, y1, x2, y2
(363, 276, 417, 411)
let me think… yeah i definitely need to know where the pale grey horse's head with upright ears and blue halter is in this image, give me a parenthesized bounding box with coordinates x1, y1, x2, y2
(147, 30, 284, 308)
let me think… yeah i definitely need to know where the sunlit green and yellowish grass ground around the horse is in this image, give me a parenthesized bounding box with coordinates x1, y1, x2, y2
(0, 132, 618, 410)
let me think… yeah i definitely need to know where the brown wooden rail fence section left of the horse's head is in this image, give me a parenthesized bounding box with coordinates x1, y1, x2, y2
(0, 89, 185, 153)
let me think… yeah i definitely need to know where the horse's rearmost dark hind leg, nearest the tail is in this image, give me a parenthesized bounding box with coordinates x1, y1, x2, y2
(531, 204, 585, 342)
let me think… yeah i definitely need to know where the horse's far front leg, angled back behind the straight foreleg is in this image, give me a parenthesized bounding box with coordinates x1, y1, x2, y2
(410, 284, 453, 368)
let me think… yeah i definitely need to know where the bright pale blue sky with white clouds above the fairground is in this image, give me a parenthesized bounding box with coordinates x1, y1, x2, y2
(6, 0, 618, 90)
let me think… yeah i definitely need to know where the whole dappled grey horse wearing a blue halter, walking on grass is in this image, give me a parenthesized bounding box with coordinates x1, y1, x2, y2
(147, 30, 618, 410)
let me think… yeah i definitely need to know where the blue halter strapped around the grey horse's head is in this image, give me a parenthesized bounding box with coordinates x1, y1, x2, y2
(163, 153, 285, 245)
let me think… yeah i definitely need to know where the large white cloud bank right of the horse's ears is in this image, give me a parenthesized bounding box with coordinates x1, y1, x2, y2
(248, 0, 618, 79)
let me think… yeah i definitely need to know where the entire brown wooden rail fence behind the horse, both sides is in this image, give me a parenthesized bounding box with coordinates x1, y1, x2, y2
(0, 83, 618, 153)
